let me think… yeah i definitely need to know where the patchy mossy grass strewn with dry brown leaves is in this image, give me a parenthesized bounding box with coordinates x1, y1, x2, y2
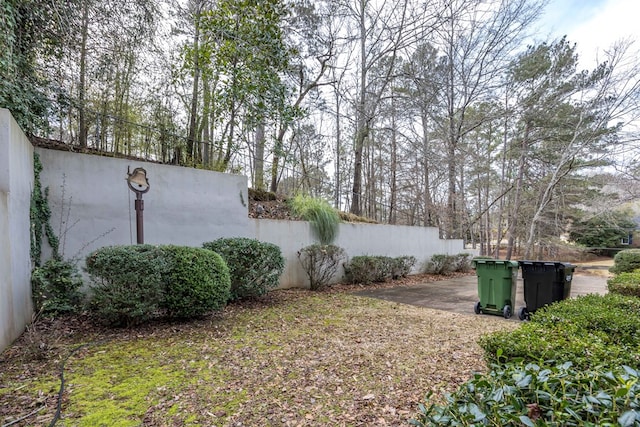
(0, 290, 517, 426)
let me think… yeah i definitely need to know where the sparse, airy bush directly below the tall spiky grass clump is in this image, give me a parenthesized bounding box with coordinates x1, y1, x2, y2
(298, 245, 347, 290)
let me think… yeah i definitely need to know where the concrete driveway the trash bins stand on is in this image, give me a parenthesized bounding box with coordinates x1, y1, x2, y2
(356, 267, 607, 320)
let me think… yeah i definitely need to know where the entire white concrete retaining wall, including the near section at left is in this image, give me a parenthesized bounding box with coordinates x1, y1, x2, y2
(0, 109, 464, 351)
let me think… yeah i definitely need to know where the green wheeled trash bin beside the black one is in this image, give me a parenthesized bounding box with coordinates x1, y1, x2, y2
(473, 259, 518, 319)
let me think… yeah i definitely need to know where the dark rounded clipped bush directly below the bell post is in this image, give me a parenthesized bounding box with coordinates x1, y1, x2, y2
(86, 245, 170, 326)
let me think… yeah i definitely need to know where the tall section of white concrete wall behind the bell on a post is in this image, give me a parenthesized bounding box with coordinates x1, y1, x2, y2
(36, 148, 249, 266)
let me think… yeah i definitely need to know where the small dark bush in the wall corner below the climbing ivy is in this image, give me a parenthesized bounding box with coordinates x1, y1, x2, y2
(31, 258, 82, 316)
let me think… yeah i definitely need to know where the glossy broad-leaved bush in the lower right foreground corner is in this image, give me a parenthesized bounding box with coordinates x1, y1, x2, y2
(410, 362, 640, 426)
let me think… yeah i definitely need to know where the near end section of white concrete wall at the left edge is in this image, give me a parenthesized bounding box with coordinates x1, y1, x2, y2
(0, 108, 33, 351)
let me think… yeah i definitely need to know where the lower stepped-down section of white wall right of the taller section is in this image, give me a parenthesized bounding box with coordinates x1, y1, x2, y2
(250, 219, 469, 288)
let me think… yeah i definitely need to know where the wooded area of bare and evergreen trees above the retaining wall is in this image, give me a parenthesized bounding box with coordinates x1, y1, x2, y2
(0, 0, 640, 258)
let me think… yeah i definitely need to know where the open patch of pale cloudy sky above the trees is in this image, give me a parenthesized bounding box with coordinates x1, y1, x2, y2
(541, 0, 640, 68)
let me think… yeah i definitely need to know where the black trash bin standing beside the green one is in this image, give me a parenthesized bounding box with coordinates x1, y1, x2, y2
(518, 261, 575, 320)
